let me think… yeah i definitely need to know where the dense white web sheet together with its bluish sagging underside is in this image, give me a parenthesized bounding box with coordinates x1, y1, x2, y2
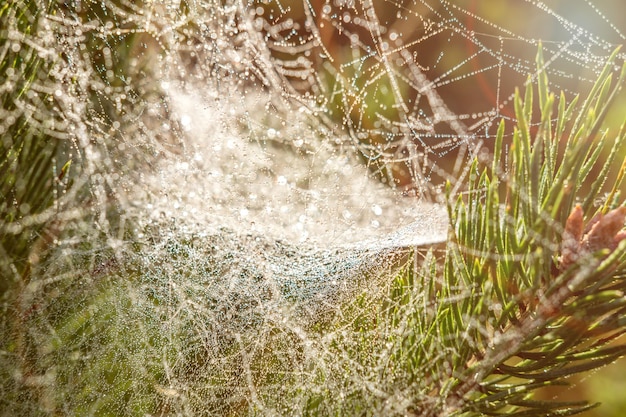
(131, 80, 448, 322)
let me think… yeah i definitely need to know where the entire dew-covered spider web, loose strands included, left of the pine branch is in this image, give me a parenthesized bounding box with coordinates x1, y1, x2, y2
(0, 0, 625, 415)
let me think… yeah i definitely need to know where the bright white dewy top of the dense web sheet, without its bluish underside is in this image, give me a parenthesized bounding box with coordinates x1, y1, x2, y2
(149, 85, 446, 247)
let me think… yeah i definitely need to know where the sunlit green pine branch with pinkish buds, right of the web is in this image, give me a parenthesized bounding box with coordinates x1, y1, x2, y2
(430, 45, 626, 416)
